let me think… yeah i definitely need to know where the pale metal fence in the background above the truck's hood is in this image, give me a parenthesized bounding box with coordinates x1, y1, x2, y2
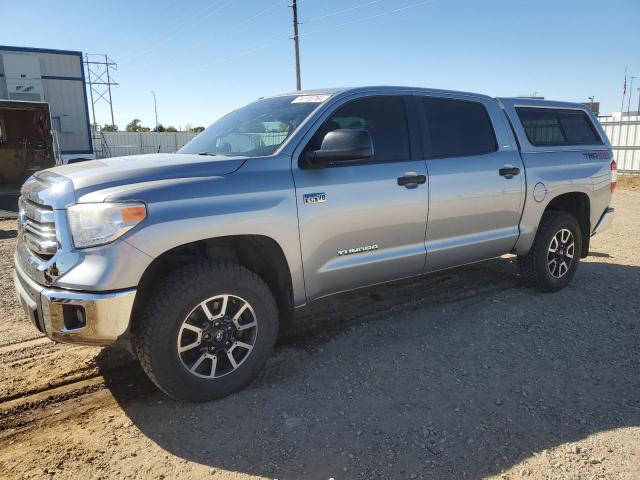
(93, 132, 197, 158)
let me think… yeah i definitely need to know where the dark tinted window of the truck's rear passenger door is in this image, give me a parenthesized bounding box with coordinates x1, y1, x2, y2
(422, 97, 497, 158)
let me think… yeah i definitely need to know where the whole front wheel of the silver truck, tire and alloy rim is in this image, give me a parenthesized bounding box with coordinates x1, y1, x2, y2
(134, 263, 278, 402)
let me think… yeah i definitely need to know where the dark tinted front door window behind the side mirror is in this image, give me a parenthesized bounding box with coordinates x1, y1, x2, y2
(307, 97, 411, 162)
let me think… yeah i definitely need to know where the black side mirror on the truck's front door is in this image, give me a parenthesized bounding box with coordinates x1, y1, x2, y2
(306, 128, 373, 167)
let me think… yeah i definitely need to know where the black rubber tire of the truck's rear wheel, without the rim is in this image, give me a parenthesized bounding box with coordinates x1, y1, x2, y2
(518, 211, 582, 292)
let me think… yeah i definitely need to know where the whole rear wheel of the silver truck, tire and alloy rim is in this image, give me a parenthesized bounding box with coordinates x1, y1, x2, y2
(518, 211, 582, 292)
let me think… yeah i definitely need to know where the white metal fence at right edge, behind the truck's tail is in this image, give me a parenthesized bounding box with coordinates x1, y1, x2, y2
(598, 114, 640, 173)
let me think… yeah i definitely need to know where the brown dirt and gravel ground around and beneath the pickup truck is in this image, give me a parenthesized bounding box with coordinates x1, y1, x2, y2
(0, 189, 640, 480)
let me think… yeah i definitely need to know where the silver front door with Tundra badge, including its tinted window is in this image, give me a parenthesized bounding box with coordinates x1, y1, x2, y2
(293, 95, 428, 300)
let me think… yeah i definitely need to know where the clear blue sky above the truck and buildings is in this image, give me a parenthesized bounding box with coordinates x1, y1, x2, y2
(0, 0, 640, 129)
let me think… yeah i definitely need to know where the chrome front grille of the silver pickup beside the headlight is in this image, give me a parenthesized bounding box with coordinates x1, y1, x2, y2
(19, 196, 58, 260)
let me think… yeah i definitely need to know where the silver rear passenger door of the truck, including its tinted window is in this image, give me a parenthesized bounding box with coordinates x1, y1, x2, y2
(419, 95, 525, 271)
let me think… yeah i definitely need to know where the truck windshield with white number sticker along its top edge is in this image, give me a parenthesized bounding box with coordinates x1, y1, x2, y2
(178, 95, 329, 157)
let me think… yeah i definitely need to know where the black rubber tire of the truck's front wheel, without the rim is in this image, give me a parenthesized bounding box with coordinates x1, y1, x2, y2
(133, 262, 278, 402)
